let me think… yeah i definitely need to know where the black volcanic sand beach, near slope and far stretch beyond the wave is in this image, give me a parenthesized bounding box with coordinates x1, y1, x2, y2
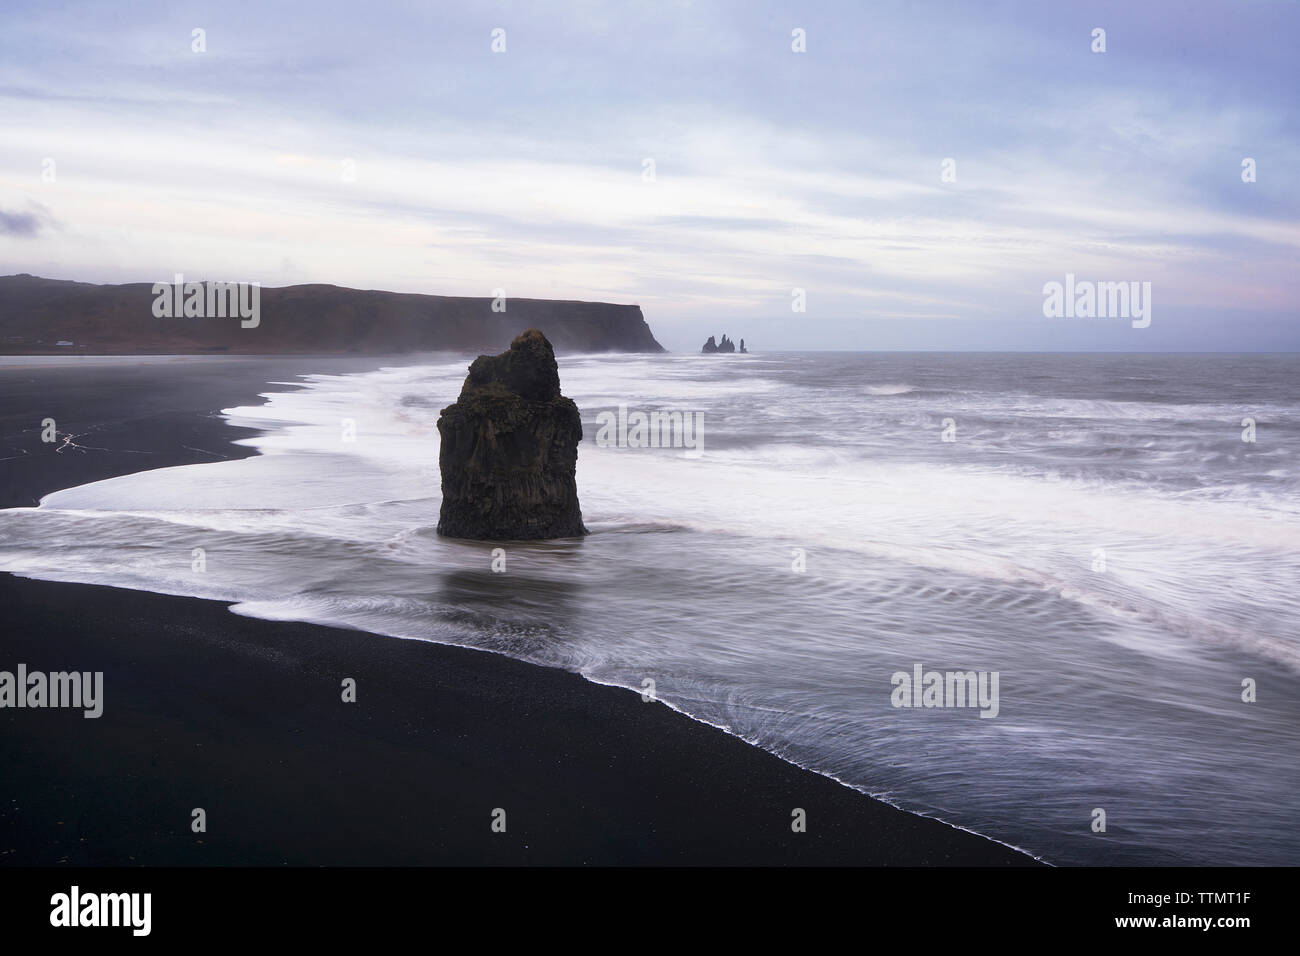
(0, 359, 1032, 865)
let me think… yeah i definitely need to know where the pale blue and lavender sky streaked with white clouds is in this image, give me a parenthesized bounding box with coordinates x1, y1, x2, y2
(0, 0, 1300, 351)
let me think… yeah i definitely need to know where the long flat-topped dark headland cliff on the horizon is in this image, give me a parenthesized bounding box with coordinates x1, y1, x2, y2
(0, 274, 664, 355)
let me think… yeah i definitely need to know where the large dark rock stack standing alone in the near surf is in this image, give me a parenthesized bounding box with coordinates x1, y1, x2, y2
(438, 329, 586, 541)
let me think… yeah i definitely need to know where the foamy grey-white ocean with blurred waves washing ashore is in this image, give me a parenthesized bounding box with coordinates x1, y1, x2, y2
(0, 352, 1300, 865)
